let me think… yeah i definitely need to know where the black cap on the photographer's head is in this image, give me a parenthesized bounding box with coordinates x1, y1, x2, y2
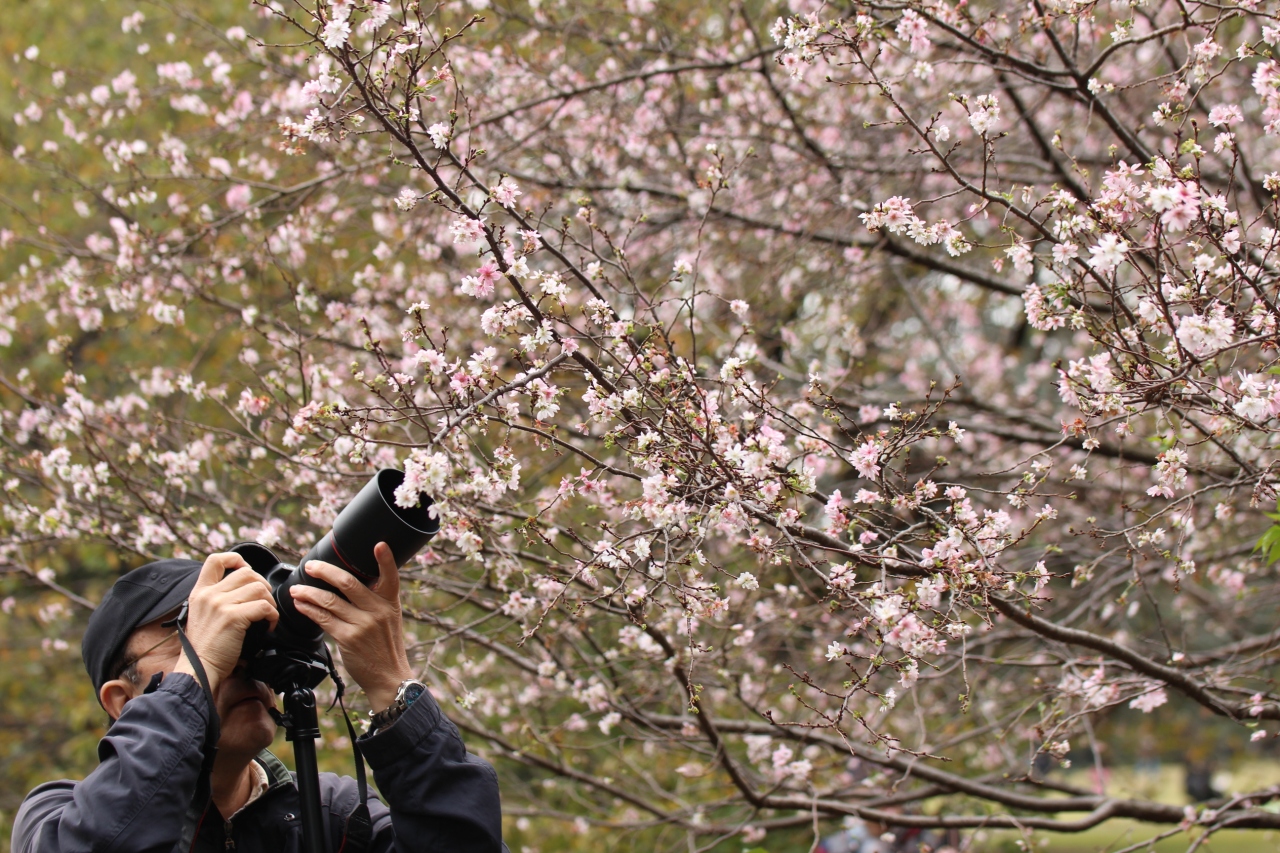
(81, 560, 200, 692)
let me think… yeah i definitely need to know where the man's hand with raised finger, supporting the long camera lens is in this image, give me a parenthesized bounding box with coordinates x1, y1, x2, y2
(289, 542, 413, 711)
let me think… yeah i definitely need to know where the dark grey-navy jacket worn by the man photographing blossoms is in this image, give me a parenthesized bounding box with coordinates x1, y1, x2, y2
(13, 675, 506, 853)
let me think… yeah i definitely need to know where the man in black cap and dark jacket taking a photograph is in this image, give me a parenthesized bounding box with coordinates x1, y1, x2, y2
(13, 543, 506, 853)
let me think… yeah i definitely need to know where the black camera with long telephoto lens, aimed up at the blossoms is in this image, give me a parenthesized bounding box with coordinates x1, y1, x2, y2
(232, 467, 440, 693)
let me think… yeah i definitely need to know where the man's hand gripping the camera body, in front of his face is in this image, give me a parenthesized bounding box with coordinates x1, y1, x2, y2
(173, 553, 280, 693)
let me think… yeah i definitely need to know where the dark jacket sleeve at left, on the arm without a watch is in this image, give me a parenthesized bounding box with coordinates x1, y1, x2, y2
(12, 675, 209, 853)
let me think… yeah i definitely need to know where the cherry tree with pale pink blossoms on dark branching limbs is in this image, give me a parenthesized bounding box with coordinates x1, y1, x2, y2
(0, 0, 1280, 849)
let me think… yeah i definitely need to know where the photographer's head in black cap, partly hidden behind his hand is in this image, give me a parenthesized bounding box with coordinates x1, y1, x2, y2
(81, 555, 275, 754)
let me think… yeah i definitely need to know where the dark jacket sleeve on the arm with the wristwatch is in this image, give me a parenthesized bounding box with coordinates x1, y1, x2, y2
(360, 692, 506, 853)
